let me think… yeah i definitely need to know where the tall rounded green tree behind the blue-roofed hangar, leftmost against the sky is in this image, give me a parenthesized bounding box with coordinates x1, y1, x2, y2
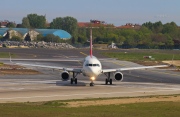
(27, 14, 46, 28)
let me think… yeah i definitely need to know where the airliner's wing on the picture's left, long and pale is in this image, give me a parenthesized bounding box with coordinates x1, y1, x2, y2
(12, 62, 81, 73)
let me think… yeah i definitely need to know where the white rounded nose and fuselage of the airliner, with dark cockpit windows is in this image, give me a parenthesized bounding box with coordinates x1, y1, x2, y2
(82, 56, 102, 78)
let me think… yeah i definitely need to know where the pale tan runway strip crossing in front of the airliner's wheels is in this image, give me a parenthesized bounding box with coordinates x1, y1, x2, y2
(0, 79, 180, 103)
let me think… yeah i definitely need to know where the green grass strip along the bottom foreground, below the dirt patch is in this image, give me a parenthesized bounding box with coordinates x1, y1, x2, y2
(0, 101, 180, 117)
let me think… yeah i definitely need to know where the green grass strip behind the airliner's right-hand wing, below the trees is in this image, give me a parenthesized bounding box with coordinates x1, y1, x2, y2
(103, 52, 180, 61)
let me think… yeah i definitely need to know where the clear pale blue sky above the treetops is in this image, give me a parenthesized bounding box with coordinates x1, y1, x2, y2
(0, 0, 180, 26)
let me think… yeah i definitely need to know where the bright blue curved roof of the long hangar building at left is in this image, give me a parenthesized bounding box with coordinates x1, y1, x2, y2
(0, 28, 71, 39)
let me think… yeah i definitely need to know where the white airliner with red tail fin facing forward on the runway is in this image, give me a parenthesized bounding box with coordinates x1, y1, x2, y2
(12, 30, 167, 86)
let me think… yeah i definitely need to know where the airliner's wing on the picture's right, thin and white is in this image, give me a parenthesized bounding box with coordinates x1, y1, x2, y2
(102, 65, 168, 73)
